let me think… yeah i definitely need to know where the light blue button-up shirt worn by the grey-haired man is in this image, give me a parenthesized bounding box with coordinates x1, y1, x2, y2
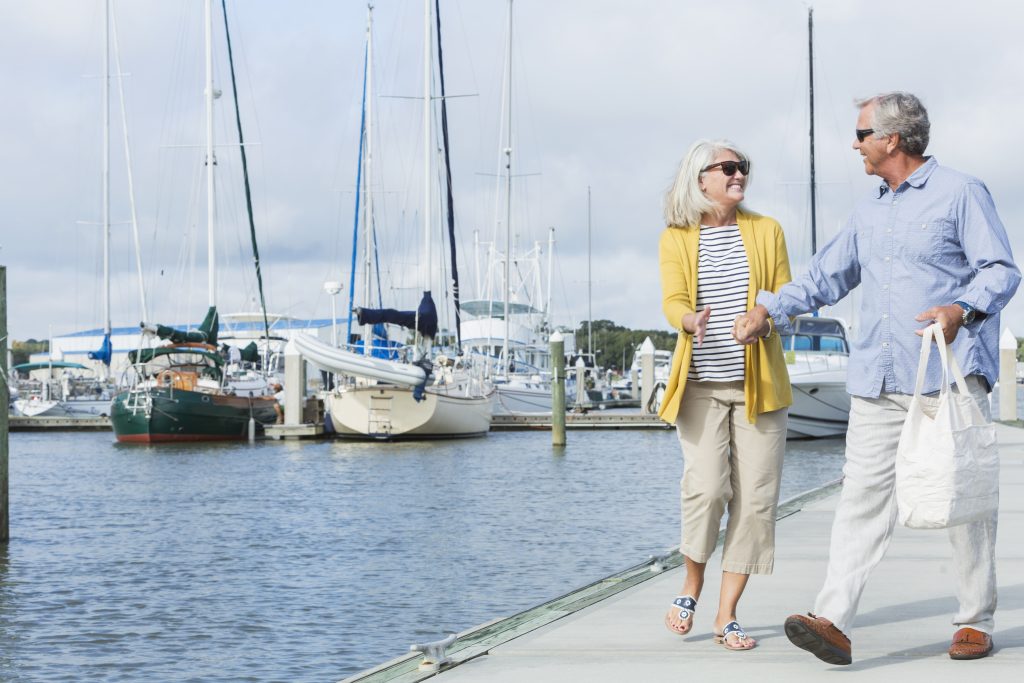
(757, 157, 1021, 397)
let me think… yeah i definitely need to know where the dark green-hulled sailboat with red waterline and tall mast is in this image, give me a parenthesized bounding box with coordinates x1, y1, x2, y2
(111, 0, 278, 443)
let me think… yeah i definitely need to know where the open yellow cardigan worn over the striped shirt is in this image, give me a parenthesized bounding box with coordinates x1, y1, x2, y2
(658, 211, 793, 423)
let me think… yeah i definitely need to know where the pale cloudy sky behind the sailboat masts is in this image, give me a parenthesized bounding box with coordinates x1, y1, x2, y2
(0, 0, 1024, 340)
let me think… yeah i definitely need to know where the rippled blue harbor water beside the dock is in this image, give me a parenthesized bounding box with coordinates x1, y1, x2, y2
(0, 431, 843, 681)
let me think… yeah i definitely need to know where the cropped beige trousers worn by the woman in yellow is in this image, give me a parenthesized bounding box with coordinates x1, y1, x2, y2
(676, 381, 788, 573)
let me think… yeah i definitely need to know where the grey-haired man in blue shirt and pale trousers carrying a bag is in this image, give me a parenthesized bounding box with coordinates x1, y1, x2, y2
(733, 92, 1021, 665)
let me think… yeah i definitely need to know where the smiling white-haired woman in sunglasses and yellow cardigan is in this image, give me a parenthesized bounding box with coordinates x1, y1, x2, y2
(659, 140, 793, 650)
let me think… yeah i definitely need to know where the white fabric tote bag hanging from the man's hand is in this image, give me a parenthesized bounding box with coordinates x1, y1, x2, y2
(896, 324, 999, 528)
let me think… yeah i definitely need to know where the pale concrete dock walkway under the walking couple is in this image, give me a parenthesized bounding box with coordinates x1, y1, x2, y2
(415, 425, 1024, 683)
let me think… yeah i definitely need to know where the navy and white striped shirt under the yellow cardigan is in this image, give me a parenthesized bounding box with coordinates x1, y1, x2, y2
(687, 225, 751, 382)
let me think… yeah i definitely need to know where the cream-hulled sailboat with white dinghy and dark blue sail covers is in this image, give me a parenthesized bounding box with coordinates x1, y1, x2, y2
(293, 0, 493, 439)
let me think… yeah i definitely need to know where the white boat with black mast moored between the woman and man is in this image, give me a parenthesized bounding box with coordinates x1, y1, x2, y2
(782, 8, 850, 438)
